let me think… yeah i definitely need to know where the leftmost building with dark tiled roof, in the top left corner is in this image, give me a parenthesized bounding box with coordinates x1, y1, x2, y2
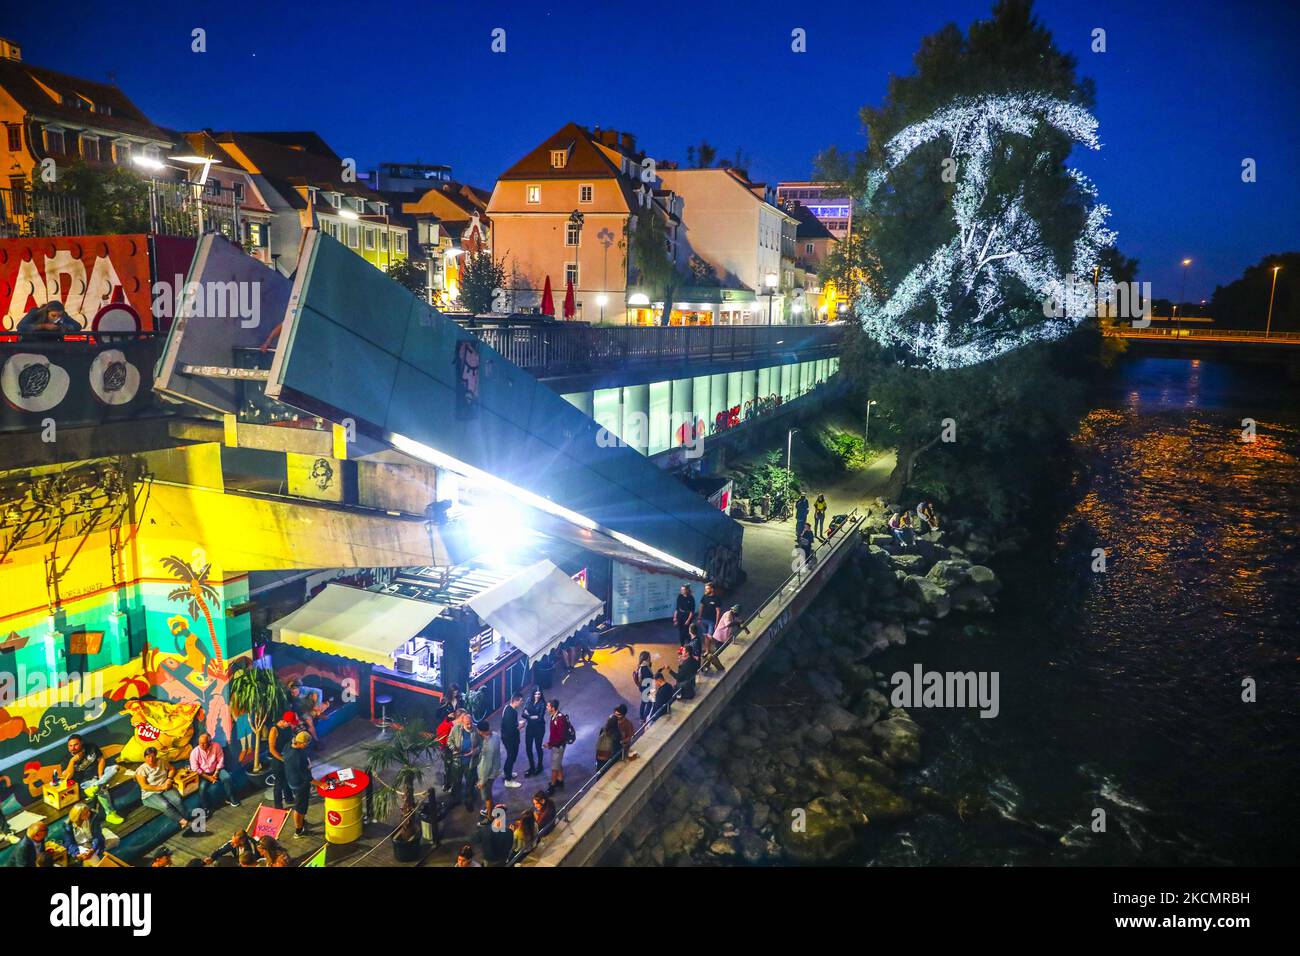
(0, 40, 173, 190)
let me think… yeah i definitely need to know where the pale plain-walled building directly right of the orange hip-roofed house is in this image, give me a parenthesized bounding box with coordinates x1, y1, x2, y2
(660, 168, 803, 324)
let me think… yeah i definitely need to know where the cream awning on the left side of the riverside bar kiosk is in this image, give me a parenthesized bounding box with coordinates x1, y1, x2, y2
(270, 584, 442, 667)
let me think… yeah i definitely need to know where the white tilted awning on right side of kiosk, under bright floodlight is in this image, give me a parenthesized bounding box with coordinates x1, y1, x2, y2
(468, 559, 605, 665)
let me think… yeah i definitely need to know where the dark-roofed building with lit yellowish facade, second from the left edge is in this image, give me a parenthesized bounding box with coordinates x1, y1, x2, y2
(207, 130, 410, 273)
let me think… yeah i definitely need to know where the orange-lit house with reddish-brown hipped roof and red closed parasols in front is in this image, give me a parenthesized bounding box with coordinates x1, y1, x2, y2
(488, 122, 676, 324)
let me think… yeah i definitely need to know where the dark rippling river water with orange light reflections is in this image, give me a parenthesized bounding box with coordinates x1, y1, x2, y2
(863, 359, 1300, 865)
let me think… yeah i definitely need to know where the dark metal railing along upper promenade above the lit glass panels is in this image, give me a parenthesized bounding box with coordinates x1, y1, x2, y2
(468, 323, 844, 375)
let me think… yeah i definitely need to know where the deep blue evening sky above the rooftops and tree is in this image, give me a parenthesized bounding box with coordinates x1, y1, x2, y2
(3, 0, 1300, 299)
